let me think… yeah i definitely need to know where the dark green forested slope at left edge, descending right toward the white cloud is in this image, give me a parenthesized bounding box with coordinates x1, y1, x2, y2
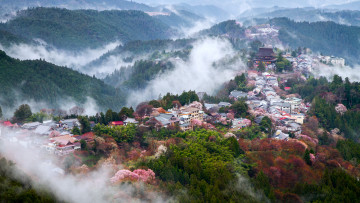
(0, 51, 125, 109)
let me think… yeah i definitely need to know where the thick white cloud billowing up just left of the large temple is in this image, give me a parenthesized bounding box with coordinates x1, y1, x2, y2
(128, 38, 245, 106)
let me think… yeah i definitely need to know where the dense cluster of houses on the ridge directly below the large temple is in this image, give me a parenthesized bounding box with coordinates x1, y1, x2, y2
(246, 71, 309, 140)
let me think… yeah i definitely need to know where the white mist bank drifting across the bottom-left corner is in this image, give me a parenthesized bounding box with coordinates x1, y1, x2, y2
(0, 127, 165, 203)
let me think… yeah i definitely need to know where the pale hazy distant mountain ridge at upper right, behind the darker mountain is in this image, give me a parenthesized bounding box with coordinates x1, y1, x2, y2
(240, 8, 360, 26)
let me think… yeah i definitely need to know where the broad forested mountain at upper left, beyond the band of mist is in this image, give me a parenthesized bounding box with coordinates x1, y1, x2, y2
(0, 7, 175, 49)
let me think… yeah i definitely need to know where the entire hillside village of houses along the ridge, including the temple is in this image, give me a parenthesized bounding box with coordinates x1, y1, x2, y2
(0, 46, 345, 156)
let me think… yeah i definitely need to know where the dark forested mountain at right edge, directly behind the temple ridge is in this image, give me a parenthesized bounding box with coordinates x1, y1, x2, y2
(270, 18, 360, 64)
